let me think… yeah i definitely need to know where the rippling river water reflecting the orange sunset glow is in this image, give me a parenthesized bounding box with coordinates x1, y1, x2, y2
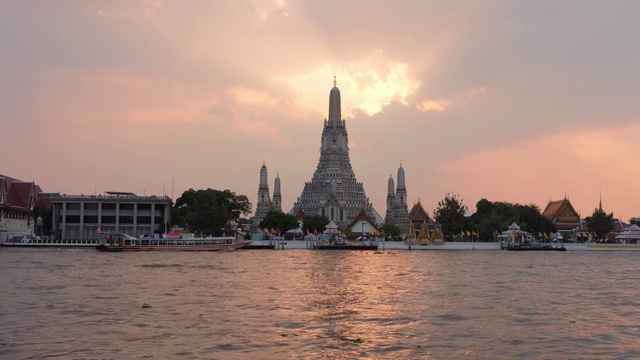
(0, 248, 640, 359)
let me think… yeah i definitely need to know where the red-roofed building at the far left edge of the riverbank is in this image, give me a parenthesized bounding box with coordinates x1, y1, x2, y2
(0, 175, 50, 241)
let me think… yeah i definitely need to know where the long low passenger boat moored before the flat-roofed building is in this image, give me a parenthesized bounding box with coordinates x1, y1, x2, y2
(96, 233, 250, 252)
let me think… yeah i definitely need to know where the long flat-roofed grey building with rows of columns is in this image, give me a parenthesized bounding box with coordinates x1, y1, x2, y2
(49, 191, 171, 240)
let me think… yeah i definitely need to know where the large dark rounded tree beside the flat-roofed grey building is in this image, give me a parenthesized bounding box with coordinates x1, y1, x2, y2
(172, 189, 251, 235)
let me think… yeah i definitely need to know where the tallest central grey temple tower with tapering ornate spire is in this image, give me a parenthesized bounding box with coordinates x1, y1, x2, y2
(289, 78, 383, 228)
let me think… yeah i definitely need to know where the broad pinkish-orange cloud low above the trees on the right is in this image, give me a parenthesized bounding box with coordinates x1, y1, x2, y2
(431, 124, 640, 220)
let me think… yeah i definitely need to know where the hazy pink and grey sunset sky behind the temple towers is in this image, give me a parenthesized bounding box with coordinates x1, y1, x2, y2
(0, 0, 640, 221)
